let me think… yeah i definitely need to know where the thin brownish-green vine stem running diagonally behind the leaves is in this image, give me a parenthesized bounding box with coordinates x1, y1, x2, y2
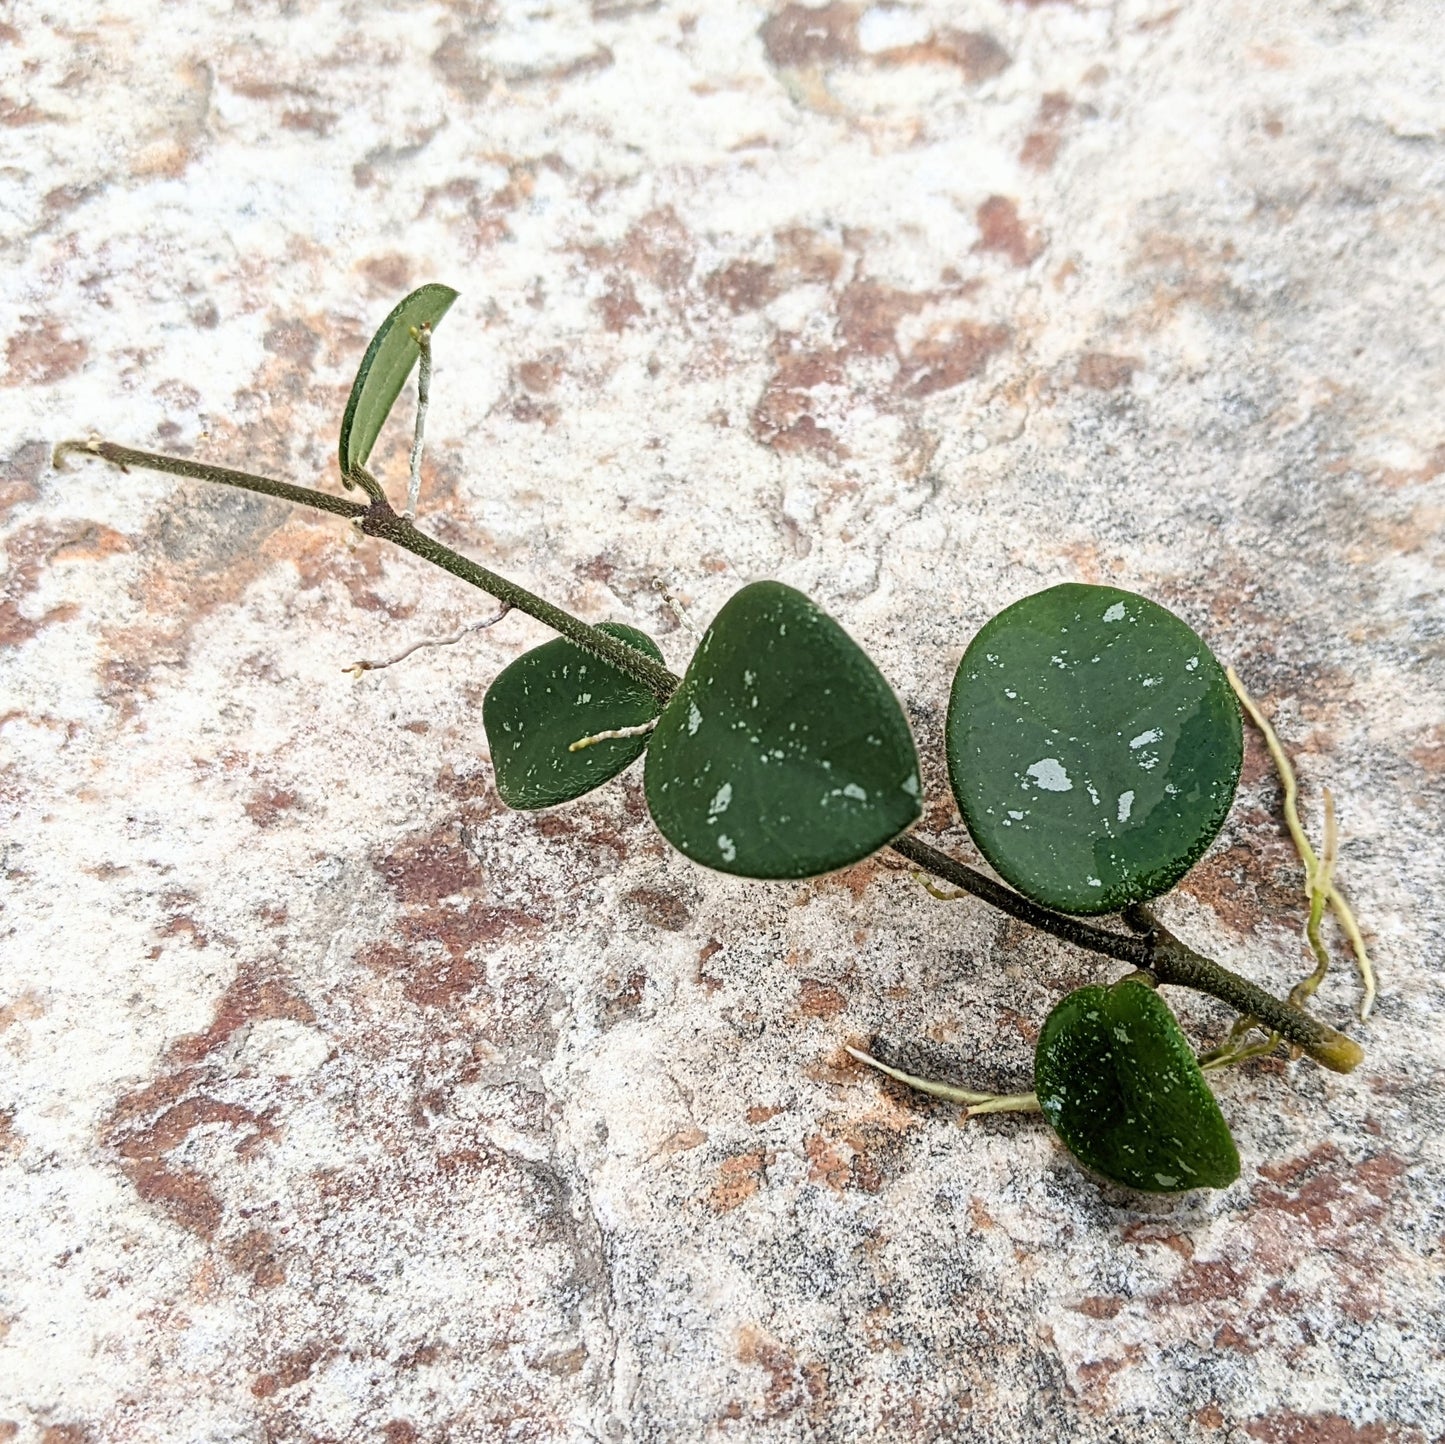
(52, 439, 1364, 1073)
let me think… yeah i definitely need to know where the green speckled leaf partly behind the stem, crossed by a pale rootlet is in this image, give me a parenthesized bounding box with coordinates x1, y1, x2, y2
(481, 622, 662, 811)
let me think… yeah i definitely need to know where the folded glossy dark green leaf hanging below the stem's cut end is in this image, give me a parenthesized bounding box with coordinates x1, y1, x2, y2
(1033, 979, 1240, 1194)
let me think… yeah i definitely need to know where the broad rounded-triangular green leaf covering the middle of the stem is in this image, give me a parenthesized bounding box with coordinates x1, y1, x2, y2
(644, 581, 919, 877)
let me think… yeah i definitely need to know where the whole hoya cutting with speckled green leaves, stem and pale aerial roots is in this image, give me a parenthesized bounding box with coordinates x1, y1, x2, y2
(56, 285, 1373, 1192)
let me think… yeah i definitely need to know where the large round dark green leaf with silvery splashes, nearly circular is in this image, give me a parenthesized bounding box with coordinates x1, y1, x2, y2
(946, 584, 1244, 914)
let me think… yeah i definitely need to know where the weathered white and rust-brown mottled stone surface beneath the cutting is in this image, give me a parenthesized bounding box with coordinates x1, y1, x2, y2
(0, 0, 1445, 1444)
